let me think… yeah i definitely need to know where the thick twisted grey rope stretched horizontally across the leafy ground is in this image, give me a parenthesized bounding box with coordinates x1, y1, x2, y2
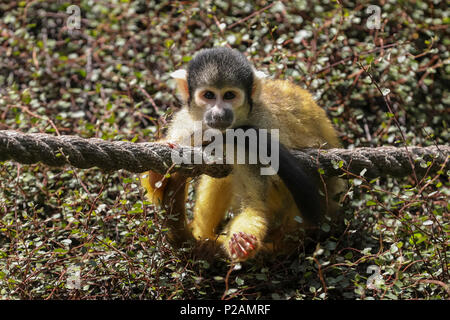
(0, 130, 450, 178)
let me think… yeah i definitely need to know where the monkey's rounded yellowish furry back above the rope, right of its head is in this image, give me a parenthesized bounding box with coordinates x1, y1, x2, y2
(255, 80, 340, 148)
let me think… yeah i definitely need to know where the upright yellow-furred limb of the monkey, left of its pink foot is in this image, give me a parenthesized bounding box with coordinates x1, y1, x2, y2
(190, 175, 232, 240)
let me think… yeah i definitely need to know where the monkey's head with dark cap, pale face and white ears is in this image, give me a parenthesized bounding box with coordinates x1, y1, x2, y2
(171, 47, 264, 131)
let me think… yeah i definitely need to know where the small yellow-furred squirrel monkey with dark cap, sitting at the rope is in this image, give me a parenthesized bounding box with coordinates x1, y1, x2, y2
(141, 48, 345, 261)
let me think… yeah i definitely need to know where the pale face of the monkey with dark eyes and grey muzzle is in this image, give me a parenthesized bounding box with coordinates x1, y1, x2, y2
(193, 87, 248, 131)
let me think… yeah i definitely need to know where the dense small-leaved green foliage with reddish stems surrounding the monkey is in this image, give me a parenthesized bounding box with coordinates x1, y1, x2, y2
(0, 0, 450, 299)
